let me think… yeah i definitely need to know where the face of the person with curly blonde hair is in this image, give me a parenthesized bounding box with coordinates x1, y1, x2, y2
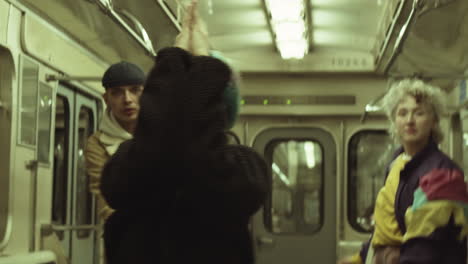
(395, 95, 436, 148)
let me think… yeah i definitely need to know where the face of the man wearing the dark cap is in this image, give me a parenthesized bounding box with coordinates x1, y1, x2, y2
(103, 85, 143, 123)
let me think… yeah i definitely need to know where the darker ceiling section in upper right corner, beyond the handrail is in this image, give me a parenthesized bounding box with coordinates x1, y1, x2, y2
(377, 0, 468, 90)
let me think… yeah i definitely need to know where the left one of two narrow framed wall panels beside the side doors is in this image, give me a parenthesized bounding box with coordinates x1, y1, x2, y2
(20, 58, 39, 146)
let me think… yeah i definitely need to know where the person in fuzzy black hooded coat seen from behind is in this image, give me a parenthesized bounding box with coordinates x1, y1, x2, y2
(101, 2, 271, 264)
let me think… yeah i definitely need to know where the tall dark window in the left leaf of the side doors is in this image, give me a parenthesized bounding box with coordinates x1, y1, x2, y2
(52, 95, 70, 240)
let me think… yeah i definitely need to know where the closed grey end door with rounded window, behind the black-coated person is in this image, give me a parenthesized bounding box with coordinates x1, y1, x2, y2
(253, 127, 337, 264)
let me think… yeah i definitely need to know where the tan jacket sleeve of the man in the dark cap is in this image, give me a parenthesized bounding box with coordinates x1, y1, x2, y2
(85, 132, 114, 220)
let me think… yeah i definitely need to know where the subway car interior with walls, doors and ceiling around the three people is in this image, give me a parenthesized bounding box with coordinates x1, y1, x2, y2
(0, 0, 468, 264)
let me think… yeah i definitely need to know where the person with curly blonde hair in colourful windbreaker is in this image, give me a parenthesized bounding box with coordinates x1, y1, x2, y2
(339, 80, 468, 264)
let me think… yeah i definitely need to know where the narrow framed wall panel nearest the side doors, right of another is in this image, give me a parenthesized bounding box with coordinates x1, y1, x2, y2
(37, 83, 52, 164)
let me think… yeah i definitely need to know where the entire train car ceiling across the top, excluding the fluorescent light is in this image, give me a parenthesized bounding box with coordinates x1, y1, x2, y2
(14, 0, 468, 81)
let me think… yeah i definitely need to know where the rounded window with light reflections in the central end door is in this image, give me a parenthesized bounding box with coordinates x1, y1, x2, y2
(264, 140, 323, 234)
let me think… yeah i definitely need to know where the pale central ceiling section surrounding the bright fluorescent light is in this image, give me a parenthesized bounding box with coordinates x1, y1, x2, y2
(200, 0, 384, 73)
